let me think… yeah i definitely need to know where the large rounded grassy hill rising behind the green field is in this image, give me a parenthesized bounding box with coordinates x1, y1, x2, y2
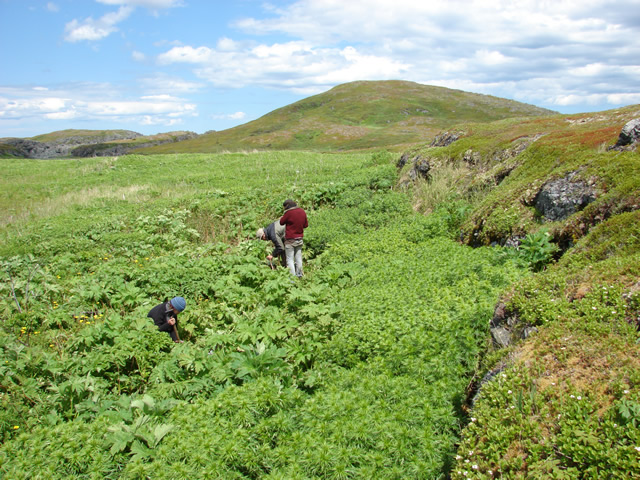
(140, 81, 554, 153)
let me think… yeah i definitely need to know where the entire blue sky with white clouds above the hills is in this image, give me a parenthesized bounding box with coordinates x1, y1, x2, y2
(0, 0, 640, 138)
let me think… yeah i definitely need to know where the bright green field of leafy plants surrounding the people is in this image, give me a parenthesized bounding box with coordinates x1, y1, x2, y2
(0, 152, 523, 478)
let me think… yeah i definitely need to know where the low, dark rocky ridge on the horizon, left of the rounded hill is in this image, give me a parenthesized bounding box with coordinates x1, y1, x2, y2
(0, 130, 198, 159)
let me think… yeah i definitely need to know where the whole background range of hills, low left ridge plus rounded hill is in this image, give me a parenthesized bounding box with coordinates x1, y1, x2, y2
(0, 80, 555, 158)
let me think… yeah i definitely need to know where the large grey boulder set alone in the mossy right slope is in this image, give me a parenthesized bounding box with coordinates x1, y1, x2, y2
(534, 172, 596, 222)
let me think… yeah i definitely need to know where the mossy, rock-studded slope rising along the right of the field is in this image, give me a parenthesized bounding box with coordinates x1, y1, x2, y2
(399, 105, 640, 479)
